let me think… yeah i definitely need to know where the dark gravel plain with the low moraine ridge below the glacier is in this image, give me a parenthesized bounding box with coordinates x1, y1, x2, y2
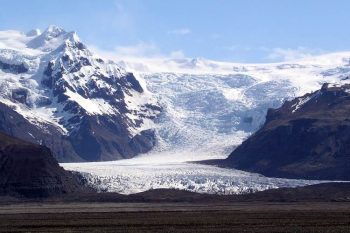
(0, 183, 350, 233)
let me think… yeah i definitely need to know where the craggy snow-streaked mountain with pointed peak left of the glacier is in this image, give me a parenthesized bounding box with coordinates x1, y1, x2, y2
(0, 26, 161, 161)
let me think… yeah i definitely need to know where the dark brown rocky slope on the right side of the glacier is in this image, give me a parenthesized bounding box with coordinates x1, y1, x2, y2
(221, 84, 350, 180)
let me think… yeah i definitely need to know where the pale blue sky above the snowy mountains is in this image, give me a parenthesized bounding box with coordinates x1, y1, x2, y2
(0, 0, 350, 62)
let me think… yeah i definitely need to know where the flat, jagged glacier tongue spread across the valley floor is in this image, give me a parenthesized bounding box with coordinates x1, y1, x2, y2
(61, 154, 321, 195)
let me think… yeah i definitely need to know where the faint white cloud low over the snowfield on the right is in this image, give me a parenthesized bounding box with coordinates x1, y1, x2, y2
(267, 47, 322, 61)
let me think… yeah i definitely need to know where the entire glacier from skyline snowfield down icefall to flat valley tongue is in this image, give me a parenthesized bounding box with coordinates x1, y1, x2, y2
(61, 52, 350, 194)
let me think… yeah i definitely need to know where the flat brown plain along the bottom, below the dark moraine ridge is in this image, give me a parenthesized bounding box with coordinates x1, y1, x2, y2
(0, 202, 350, 232)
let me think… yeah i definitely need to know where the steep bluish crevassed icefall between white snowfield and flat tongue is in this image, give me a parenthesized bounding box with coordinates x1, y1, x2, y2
(143, 73, 297, 160)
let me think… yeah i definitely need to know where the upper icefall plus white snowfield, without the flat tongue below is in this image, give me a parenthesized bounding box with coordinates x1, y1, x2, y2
(112, 52, 350, 161)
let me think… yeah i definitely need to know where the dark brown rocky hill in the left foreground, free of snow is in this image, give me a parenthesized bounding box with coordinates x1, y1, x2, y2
(0, 133, 82, 197)
